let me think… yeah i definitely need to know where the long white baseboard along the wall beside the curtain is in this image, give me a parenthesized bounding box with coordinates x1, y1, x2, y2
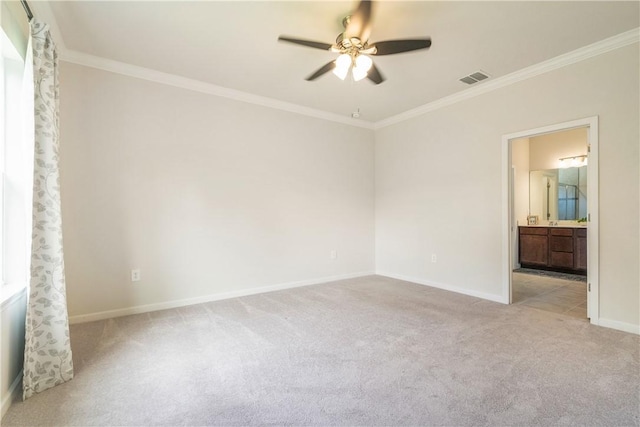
(69, 271, 375, 325)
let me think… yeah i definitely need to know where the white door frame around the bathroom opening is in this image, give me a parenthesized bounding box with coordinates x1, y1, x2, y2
(502, 116, 600, 325)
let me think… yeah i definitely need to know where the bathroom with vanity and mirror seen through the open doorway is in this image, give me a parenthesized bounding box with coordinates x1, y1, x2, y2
(511, 127, 589, 319)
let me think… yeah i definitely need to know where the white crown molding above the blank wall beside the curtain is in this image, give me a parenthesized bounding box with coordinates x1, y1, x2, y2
(60, 49, 374, 129)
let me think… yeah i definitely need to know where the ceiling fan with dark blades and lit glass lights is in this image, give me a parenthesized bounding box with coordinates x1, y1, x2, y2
(278, 0, 431, 84)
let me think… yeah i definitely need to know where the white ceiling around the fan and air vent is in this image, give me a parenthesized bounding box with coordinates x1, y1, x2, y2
(35, 1, 640, 122)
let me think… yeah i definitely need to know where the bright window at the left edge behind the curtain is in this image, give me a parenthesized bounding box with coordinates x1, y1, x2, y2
(0, 29, 33, 302)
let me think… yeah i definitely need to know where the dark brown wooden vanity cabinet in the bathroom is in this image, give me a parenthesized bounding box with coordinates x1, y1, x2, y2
(518, 227, 587, 274)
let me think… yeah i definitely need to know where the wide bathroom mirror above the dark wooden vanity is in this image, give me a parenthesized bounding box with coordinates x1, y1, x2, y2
(529, 166, 587, 221)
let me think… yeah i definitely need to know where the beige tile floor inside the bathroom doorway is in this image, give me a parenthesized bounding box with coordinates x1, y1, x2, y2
(512, 272, 587, 319)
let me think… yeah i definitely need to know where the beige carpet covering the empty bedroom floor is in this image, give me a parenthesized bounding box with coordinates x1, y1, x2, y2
(2, 276, 640, 426)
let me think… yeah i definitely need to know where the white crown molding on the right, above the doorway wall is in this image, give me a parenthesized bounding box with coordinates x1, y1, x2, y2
(374, 28, 640, 130)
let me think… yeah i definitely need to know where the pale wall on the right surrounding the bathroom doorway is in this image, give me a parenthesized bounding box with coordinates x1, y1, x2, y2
(376, 43, 640, 331)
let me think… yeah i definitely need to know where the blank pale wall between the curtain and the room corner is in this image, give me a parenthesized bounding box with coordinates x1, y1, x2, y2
(60, 62, 374, 321)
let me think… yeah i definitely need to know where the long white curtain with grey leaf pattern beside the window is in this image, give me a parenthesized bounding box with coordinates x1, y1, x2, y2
(23, 19, 73, 399)
